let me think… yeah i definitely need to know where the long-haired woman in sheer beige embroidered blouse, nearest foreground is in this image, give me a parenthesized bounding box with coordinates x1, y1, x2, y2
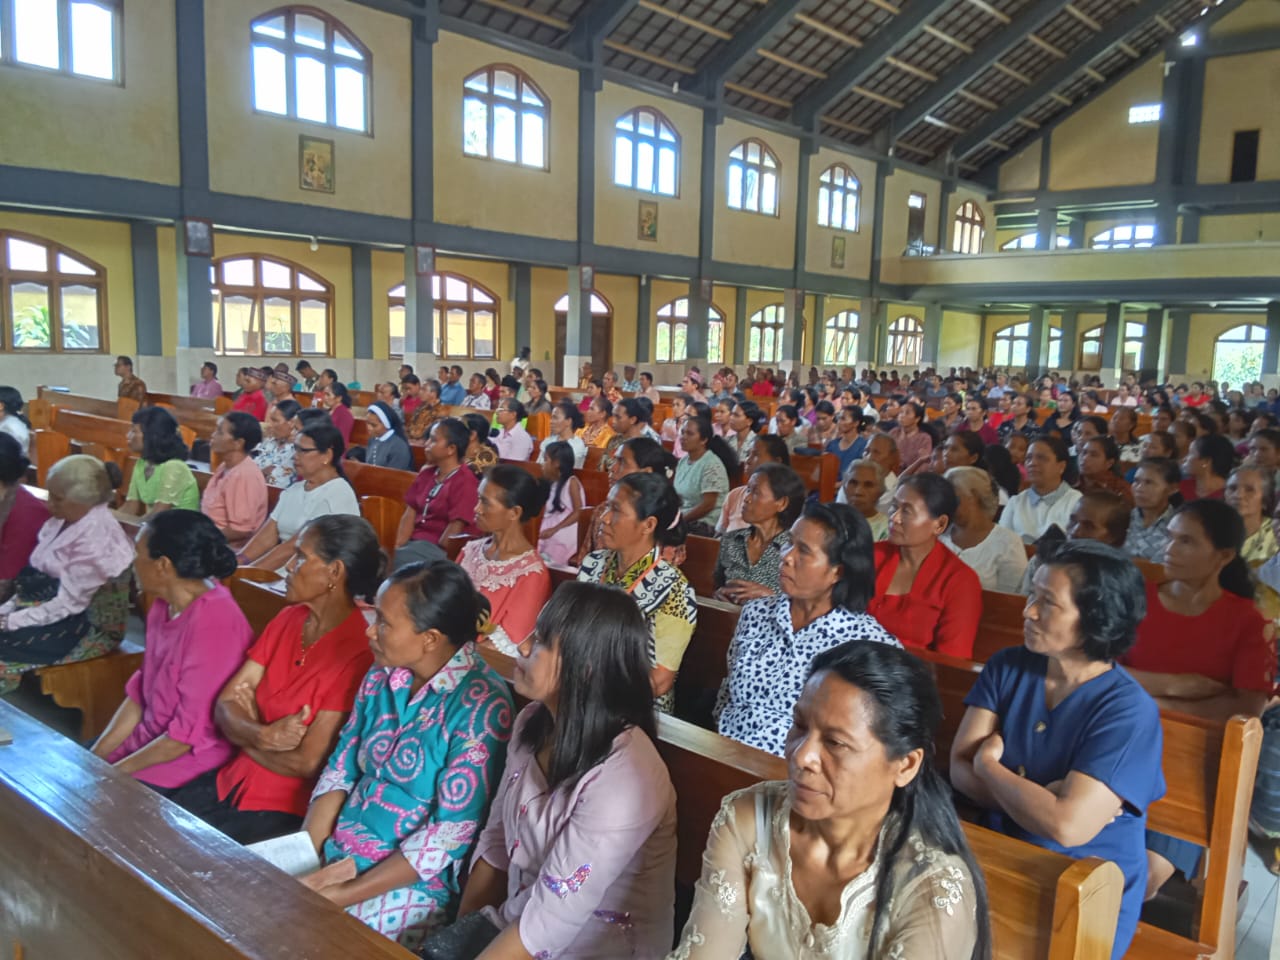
(672, 641, 991, 960)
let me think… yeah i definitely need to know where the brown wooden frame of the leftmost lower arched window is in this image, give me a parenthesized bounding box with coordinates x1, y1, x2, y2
(0, 230, 108, 353)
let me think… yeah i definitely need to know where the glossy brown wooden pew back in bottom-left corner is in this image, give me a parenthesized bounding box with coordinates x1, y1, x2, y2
(0, 703, 412, 960)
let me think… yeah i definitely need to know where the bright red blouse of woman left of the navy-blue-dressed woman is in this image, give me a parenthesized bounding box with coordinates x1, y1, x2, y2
(867, 541, 982, 660)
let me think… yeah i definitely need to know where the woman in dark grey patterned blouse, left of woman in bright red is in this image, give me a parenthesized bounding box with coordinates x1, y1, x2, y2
(716, 463, 806, 605)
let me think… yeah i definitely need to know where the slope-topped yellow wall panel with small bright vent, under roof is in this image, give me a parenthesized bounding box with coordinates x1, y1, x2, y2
(1048, 56, 1167, 189)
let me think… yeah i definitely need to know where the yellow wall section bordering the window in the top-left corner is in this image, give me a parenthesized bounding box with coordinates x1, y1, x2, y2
(0, 0, 180, 184)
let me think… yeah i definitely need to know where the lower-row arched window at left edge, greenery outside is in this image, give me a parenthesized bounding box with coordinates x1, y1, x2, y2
(0, 230, 106, 353)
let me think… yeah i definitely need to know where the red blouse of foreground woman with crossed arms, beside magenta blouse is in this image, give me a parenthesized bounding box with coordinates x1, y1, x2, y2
(218, 604, 374, 817)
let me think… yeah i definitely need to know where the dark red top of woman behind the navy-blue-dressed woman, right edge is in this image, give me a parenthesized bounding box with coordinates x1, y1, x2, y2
(1120, 584, 1276, 694)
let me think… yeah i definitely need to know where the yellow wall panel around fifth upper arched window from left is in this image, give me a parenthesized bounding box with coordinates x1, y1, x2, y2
(712, 119, 800, 269)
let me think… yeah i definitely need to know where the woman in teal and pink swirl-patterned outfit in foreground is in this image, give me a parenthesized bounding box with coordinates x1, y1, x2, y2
(302, 562, 512, 950)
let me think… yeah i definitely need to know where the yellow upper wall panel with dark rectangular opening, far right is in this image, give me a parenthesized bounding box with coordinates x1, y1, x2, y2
(1196, 50, 1280, 183)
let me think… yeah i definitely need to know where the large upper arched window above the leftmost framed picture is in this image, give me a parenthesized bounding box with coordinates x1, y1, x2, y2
(250, 6, 374, 133)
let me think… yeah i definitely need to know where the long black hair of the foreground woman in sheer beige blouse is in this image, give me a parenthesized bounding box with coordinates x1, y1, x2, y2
(809, 642, 993, 960)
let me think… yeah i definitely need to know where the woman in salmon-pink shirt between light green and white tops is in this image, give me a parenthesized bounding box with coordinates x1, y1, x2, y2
(200, 414, 267, 544)
